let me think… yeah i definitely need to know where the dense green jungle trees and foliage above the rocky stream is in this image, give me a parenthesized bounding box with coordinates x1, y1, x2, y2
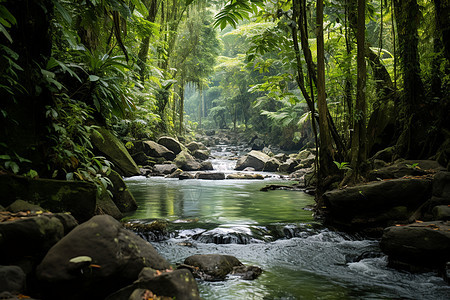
(0, 0, 450, 198)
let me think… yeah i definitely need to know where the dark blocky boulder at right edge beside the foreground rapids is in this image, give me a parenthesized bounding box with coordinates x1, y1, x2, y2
(380, 221, 450, 271)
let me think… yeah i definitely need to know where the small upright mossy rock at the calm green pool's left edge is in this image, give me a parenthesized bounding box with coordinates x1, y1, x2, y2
(108, 171, 137, 213)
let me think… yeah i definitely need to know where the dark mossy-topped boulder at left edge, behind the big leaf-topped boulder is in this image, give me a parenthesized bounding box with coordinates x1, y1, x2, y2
(0, 215, 65, 264)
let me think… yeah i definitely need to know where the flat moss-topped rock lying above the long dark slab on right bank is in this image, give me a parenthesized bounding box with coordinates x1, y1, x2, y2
(368, 160, 444, 180)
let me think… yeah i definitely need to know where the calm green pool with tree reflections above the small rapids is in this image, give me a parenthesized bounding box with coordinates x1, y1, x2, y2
(122, 177, 314, 224)
